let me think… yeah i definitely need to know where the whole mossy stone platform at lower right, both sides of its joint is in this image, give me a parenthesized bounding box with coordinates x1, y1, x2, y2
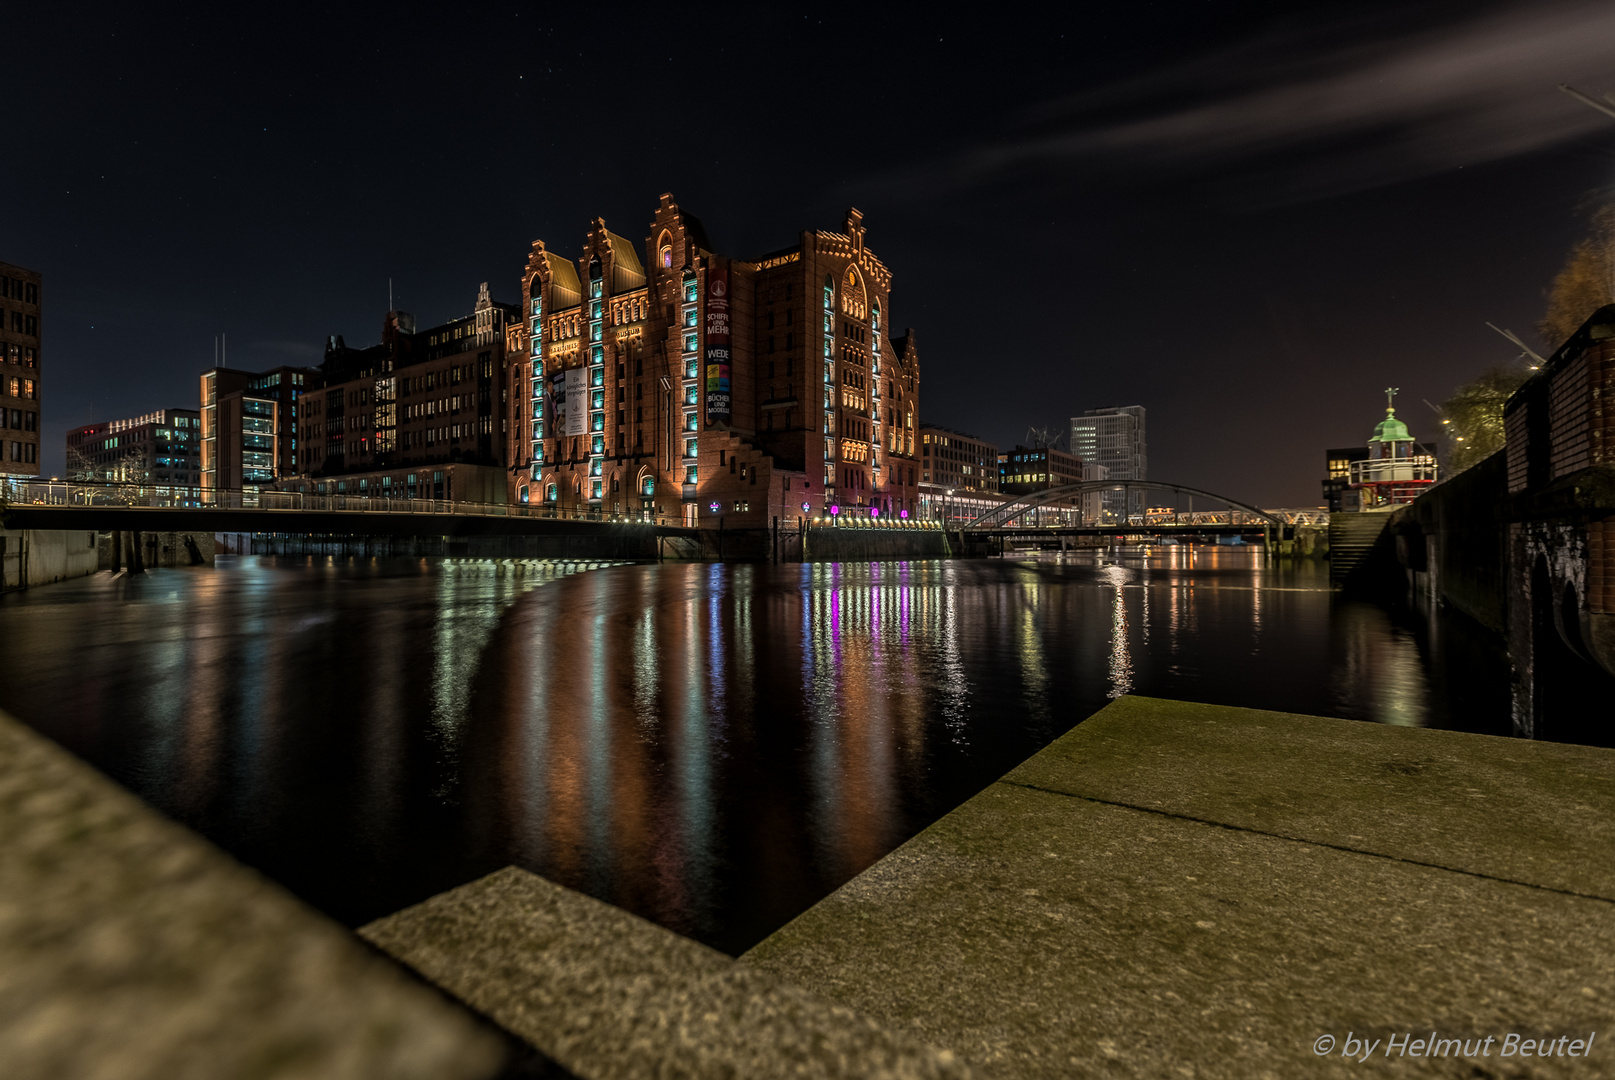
(741, 699, 1615, 1078)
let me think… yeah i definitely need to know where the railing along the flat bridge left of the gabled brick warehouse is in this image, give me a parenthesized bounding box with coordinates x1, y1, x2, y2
(0, 479, 682, 531)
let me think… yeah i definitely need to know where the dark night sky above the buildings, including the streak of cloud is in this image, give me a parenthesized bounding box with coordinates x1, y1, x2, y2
(9, 3, 1615, 507)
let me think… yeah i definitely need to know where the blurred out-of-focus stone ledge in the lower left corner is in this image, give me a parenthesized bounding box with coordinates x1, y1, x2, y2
(0, 714, 505, 1080)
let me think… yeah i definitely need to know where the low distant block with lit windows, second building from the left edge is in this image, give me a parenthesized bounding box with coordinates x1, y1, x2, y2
(66, 408, 202, 488)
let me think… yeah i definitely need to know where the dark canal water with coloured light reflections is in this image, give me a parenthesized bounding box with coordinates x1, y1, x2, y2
(0, 547, 1508, 952)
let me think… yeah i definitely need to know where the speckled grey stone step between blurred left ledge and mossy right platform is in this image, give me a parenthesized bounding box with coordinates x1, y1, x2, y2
(359, 867, 969, 1080)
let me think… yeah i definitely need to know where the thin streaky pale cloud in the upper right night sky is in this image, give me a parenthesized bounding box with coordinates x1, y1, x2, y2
(904, 3, 1615, 197)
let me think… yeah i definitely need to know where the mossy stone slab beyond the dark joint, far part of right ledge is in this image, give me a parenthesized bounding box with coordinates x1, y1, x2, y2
(1003, 697, 1615, 899)
